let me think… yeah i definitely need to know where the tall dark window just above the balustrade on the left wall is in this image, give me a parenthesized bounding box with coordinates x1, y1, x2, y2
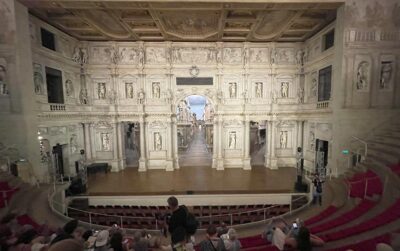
(46, 67, 64, 104)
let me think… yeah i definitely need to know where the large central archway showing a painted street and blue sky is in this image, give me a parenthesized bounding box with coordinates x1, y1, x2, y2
(176, 95, 214, 167)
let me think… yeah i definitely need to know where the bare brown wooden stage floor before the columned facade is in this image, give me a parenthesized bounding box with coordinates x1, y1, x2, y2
(87, 167, 296, 196)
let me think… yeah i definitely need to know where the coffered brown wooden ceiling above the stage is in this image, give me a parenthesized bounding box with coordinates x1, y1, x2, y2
(21, 0, 341, 42)
